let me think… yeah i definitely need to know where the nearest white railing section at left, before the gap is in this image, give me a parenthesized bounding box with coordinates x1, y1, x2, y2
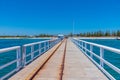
(0, 46, 21, 80)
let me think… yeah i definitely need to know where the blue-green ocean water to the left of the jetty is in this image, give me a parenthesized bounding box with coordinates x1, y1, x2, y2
(0, 39, 48, 80)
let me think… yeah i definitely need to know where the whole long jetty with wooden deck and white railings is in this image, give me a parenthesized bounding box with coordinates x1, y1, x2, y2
(0, 35, 120, 80)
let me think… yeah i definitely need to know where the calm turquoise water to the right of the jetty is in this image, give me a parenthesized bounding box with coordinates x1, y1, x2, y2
(82, 39, 120, 80)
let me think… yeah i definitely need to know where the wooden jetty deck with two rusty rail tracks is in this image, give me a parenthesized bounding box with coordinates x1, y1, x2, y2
(9, 39, 108, 80)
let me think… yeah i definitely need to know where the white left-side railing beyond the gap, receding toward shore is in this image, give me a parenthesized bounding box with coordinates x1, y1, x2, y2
(22, 39, 60, 66)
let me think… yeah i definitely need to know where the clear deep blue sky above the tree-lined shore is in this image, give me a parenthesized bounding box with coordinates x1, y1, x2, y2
(0, 0, 120, 35)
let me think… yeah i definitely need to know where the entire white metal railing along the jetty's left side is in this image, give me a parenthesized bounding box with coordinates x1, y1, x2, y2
(0, 38, 61, 80)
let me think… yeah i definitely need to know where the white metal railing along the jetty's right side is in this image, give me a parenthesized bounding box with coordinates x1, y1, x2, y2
(72, 38, 120, 80)
